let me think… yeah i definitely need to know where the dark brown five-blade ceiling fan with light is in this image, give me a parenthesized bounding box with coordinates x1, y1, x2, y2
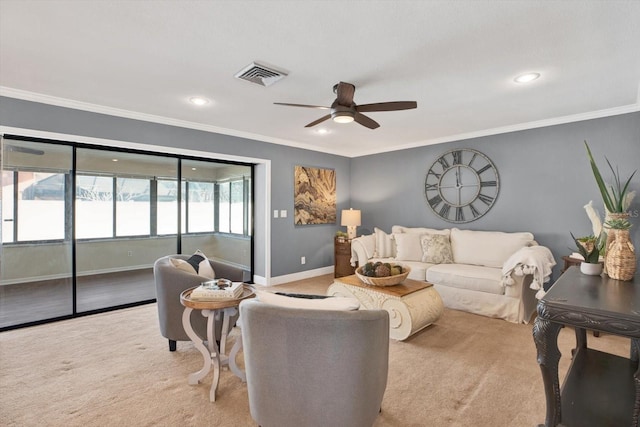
(274, 82, 418, 129)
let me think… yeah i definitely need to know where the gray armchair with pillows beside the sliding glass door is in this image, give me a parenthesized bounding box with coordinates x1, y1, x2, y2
(153, 255, 244, 351)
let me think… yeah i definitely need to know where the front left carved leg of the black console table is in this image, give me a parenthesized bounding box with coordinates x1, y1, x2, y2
(533, 316, 562, 427)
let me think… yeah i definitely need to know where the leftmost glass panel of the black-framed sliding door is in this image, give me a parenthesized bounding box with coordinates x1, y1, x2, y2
(0, 140, 73, 327)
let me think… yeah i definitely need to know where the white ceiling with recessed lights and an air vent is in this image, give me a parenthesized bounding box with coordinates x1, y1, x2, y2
(0, 0, 640, 157)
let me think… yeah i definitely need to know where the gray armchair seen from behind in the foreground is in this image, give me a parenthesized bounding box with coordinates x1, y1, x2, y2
(240, 300, 389, 427)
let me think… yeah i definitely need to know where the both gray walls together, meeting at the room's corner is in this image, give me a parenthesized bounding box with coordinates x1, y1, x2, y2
(0, 97, 640, 277)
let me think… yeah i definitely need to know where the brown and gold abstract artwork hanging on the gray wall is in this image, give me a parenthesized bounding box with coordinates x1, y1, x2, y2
(293, 166, 337, 225)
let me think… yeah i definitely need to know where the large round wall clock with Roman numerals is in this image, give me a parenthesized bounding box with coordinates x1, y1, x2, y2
(424, 148, 500, 223)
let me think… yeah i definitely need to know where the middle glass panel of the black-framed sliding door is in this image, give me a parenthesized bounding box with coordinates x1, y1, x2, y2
(74, 148, 179, 313)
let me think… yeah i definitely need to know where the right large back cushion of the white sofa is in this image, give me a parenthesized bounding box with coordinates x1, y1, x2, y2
(451, 228, 534, 268)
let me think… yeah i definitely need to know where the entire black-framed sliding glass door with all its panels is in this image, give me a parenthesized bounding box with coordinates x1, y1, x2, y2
(0, 137, 253, 330)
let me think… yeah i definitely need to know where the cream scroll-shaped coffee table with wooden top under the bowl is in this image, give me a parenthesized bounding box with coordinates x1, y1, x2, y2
(327, 275, 444, 340)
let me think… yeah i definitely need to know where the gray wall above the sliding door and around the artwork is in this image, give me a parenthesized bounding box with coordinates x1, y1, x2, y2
(0, 97, 350, 277)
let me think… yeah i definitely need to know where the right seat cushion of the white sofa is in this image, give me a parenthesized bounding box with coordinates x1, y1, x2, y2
(427, 264, 504, 295)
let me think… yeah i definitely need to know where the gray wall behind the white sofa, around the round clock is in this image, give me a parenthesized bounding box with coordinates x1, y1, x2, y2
(351, 112, 640, 278)
